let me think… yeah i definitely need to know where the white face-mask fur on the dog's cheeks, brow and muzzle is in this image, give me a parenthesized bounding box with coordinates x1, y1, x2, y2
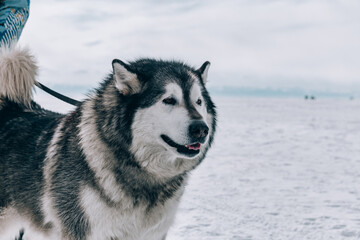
(130, 80, 212, 179)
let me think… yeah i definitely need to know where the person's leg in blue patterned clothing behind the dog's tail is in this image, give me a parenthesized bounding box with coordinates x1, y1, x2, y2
(0, 0, 29, 46)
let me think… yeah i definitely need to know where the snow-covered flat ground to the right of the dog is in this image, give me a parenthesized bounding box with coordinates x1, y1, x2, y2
(168, 98, 360, 240)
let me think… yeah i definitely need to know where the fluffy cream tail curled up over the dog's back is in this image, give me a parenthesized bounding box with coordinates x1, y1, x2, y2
(0, 44, 38, 107)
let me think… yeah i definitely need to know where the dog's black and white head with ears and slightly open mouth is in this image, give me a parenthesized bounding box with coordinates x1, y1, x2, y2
(109, 59, 216, 177)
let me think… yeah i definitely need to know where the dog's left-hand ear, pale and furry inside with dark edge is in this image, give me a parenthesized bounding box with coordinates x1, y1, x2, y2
(112, 59, 141, 95)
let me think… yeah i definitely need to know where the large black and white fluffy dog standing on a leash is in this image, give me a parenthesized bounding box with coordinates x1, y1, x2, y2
(0, 45, 216, 240)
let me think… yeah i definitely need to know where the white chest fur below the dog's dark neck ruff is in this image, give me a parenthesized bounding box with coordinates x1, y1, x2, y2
(81, 187, 183, 240)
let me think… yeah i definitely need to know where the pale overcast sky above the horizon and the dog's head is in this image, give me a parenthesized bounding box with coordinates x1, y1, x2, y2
(20, 0, 360, 96)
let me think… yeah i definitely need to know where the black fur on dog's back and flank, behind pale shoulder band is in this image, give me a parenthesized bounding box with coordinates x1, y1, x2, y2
(0, 100, 60, 226)
